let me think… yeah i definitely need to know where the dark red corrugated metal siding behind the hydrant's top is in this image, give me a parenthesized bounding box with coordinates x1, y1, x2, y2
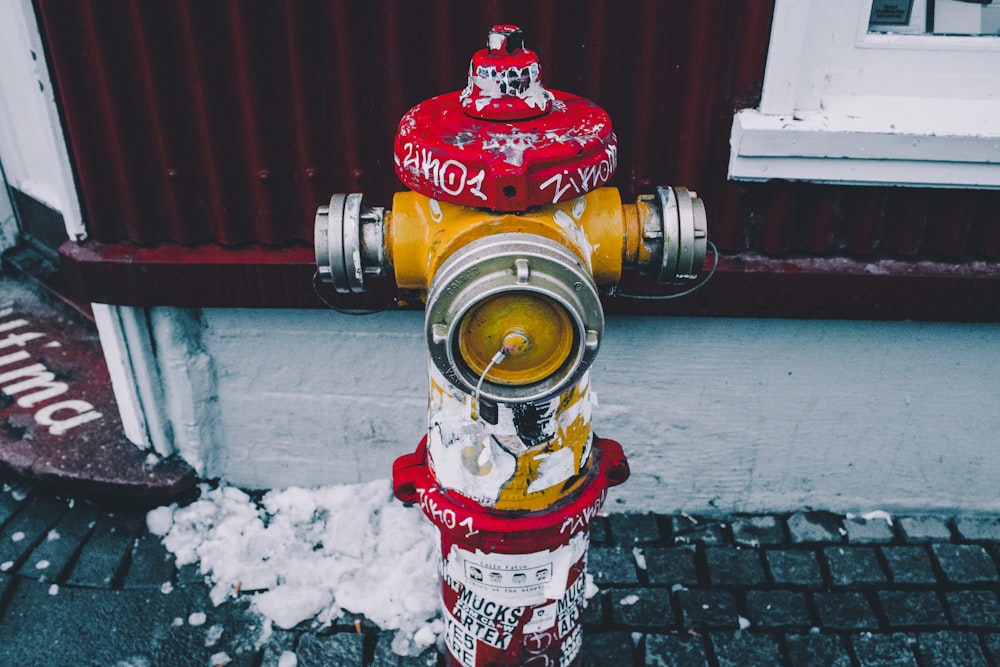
(36, 0, 1000, 261)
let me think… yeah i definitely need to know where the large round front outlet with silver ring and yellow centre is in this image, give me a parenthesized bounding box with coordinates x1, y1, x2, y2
(425, 233, 604, 403)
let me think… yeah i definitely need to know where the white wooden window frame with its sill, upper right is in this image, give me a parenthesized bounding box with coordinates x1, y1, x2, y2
(729, 0, 1000, 188)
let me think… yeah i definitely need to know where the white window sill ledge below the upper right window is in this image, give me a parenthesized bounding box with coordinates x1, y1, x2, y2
(729, 99, 1000, 189)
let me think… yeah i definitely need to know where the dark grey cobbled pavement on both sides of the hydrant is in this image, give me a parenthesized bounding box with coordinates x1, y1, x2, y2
(0, 474, 1000, 667)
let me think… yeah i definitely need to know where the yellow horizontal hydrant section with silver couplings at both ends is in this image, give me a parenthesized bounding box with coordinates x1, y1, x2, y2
(314, 187, 707, 293)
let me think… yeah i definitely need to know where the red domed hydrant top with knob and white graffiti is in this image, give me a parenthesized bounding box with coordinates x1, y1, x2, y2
(393, 25, 618, 212)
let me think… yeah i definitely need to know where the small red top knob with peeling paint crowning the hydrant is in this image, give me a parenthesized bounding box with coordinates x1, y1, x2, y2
(460, 24, 553, 121)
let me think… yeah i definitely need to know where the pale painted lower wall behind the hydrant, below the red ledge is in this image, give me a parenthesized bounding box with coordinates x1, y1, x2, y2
(139, 309, 1000, 512)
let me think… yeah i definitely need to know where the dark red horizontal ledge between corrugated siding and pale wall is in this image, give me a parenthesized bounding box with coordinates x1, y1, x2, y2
(60, 242, 1000, 322)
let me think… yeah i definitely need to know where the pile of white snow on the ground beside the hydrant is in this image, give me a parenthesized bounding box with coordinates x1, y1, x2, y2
(147, 480, 442, 655)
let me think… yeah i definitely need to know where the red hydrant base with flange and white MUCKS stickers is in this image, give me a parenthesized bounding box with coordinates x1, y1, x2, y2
(393, 438, 628, 667)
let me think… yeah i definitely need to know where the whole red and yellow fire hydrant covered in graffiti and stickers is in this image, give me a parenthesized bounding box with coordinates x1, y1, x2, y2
(315, 25, 707, 667)
